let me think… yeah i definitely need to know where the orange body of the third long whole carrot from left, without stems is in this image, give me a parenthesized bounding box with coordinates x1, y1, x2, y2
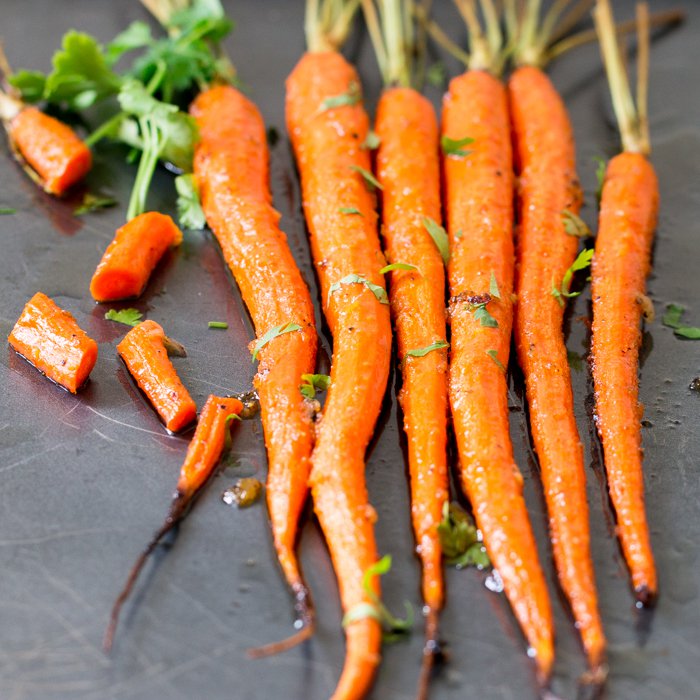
(375, 88, 447, 610)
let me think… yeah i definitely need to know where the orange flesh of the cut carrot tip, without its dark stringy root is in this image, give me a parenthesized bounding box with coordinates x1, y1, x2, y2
(177, 395, 243, 498)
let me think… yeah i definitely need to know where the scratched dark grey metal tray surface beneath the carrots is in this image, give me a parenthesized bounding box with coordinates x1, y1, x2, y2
(0, 0, 700, 700)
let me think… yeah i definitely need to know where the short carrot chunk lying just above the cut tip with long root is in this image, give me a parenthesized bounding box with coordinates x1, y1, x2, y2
(117, 321, 197, 433)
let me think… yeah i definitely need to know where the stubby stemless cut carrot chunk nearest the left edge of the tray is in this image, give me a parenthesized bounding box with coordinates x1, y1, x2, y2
(8, 292, 97, 394)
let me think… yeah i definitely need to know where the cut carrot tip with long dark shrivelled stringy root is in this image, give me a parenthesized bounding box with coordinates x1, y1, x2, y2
(103, 394, 243, 652)
